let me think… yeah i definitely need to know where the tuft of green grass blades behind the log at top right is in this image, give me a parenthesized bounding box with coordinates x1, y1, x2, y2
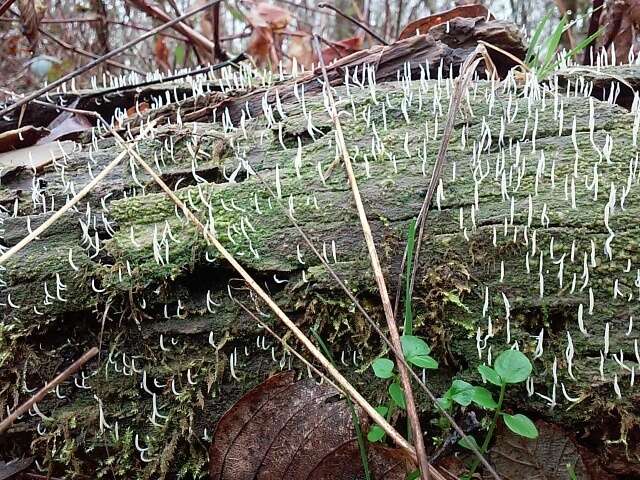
(524, 11, 603, 80)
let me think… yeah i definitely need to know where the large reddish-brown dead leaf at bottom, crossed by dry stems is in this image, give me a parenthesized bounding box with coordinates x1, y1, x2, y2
(209, 372, 411, 480)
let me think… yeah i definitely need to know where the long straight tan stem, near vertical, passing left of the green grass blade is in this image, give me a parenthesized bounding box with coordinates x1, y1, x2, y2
(314, 36, 431, 480)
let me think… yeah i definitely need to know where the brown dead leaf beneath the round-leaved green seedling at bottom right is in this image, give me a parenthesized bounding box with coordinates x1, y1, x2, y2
(491, 420, 589, 480)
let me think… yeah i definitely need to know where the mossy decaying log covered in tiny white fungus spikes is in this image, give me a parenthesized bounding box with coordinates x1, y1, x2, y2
(0, 73, 640, 478)
